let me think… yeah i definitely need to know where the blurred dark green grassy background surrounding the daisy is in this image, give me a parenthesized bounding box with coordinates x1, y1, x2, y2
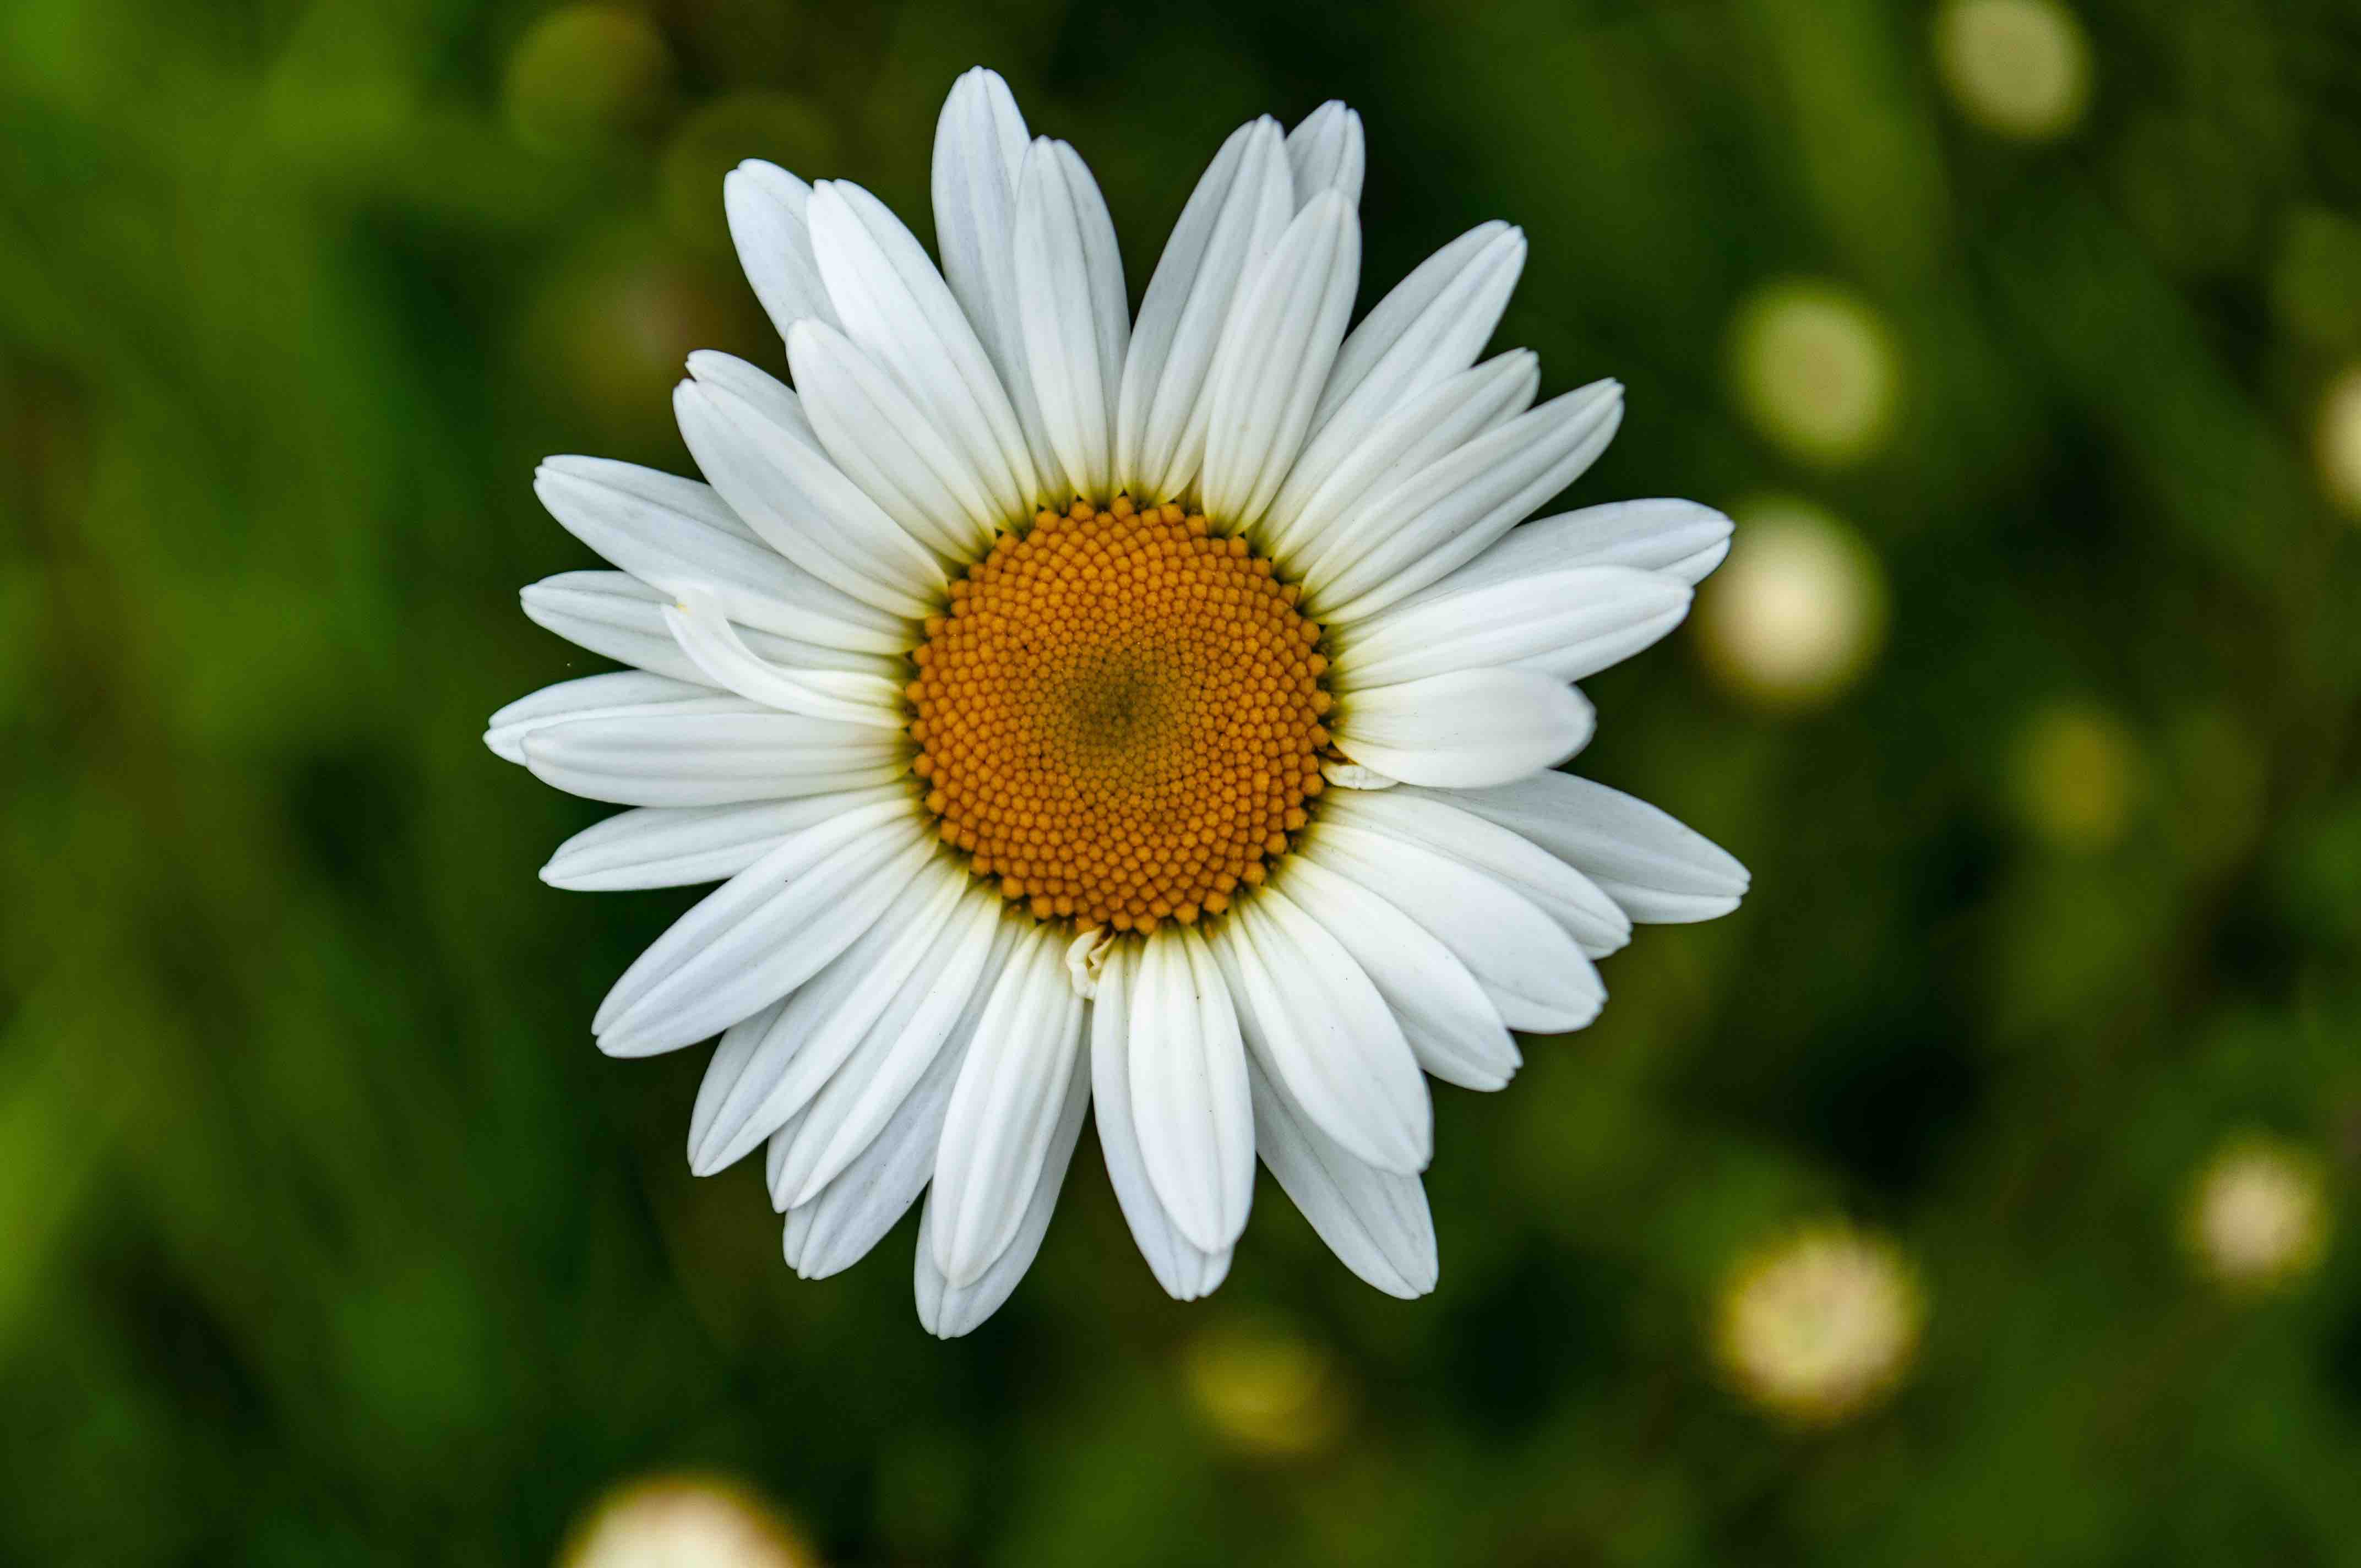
(0, 0, 2361, 1568)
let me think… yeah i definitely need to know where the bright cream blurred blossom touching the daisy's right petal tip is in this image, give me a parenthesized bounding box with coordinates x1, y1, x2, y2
(1698, 500, 1886, 709)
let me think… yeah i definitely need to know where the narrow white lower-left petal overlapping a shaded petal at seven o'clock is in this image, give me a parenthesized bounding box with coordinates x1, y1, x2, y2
(770, 888, 1015, 1209)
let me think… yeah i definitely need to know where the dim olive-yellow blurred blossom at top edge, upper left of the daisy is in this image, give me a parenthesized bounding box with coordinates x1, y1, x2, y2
(503, 5, 673, 154)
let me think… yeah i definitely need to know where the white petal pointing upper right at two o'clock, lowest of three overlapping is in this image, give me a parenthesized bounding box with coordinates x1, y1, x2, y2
(1313, 380, 1622, 621)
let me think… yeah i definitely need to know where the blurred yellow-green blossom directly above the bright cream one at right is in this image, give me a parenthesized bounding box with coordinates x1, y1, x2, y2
(1731, 281, 1901, 465)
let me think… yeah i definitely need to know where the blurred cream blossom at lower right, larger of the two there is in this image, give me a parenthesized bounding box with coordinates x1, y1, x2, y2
(1714, 1221, 1927, 1427)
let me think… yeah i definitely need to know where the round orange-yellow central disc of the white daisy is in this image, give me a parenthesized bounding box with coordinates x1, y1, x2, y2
(909, 498, 1329, 930)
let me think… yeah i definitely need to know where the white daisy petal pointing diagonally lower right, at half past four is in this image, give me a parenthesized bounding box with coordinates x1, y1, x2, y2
(1285, 855, 1523, 1088)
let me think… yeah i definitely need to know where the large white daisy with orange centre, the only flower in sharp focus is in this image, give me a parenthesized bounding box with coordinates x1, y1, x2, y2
(486, 71, 1747, 1337)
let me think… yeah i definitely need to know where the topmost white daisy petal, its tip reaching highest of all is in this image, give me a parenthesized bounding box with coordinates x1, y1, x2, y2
(933, 66, 1053, 480)
